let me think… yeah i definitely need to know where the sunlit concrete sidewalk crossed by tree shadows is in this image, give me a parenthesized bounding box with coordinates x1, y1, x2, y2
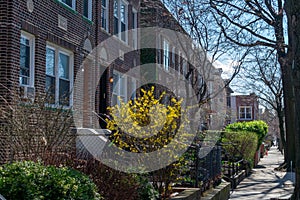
(230, 147, 295, 200)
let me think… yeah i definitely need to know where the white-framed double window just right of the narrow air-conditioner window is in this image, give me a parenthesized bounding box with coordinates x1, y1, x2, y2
(46, 45, 73, 106)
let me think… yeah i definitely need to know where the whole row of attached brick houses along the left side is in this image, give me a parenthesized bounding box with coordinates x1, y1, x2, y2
(0, 0, 232, 163)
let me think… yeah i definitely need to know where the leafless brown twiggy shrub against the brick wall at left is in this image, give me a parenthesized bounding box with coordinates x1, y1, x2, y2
(0, 91, 75, 165)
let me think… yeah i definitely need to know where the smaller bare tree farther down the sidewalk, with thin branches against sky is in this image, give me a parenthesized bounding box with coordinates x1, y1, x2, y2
(236, 47, 289, 164)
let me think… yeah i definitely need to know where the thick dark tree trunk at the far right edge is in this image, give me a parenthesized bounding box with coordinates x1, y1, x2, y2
(285, 0, 300, 200)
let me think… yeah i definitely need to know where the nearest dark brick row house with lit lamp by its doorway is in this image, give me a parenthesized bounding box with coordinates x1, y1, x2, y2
(0, 0, 139, 162)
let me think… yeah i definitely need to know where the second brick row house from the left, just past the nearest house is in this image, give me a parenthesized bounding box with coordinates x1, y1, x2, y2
(140, 0, 204, 101)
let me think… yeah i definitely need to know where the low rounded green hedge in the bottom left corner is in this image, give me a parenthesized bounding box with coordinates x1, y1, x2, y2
(0, 161, 102, 200)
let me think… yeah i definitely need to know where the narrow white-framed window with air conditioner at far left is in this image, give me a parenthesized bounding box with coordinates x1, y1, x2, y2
(19, 32, 34, 86)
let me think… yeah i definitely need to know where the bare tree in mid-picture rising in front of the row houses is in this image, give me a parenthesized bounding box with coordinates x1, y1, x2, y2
(162, 0, 249, 128)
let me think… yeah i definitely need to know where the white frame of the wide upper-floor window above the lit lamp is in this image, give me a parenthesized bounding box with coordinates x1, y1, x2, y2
(113, 0, 128, 44)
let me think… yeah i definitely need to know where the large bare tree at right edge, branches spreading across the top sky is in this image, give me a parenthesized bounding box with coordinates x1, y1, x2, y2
(162, 0, 300, 199)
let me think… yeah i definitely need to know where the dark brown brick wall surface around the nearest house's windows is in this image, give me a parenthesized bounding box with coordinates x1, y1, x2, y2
(0, 0, 139, 162)
